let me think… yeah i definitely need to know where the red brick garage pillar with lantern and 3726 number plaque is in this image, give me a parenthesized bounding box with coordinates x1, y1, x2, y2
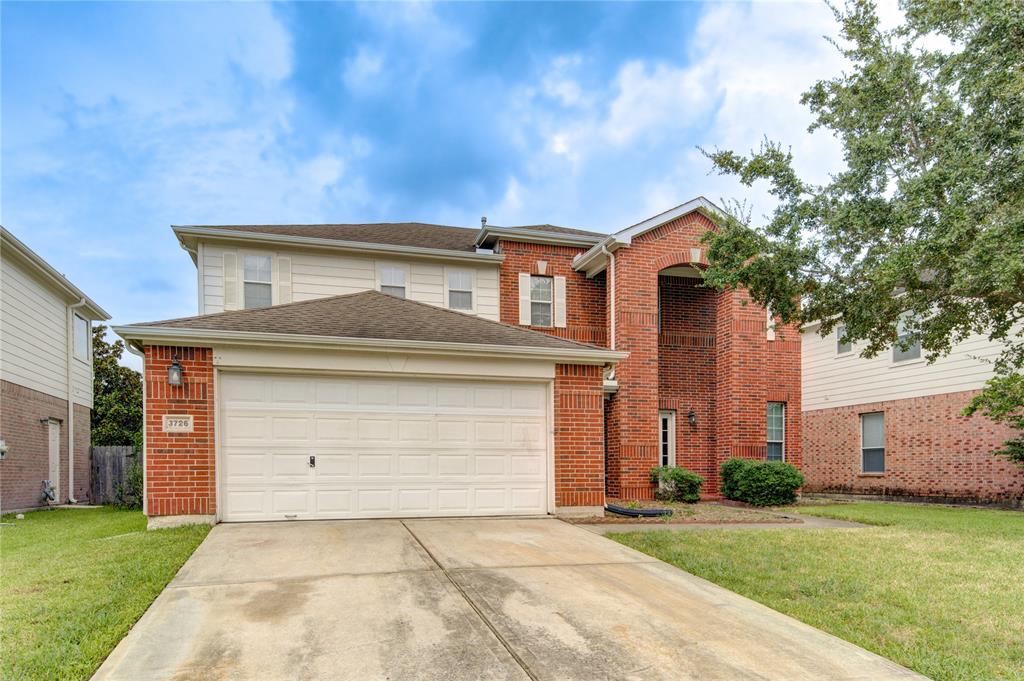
(145, 346, 217, 516)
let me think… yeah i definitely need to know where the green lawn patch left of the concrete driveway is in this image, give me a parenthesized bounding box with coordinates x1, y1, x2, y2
(0, 508, 210, 681)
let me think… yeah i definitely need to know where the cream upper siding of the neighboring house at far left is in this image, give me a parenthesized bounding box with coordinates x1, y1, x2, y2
(0, 251, 92, 409)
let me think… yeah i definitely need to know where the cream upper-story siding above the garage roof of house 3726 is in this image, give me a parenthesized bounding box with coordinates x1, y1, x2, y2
(199, 244, 499, 320)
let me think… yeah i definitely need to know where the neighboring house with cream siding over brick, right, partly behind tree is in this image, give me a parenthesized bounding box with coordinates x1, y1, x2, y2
(803, 325, 1024, 502)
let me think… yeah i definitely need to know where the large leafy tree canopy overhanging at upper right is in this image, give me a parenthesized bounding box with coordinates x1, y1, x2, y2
(707, 0, 1024, 462)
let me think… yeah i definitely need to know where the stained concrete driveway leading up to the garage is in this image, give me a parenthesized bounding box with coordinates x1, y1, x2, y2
(94, 518, 923, 681)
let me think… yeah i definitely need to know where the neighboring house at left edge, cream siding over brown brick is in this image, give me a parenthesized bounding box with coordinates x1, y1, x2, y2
(0, 226, 110, 511)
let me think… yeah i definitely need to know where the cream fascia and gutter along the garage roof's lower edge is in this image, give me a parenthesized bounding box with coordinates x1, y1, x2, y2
(114, 326, 629, 365)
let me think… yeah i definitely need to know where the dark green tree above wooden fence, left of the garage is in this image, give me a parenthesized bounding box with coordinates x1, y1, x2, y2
(92, 324, 142, 452)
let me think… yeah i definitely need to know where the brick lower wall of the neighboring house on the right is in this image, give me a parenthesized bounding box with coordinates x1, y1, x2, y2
(804, 390, 1024, 503)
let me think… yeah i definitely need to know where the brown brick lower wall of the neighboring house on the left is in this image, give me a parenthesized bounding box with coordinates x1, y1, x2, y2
(0, 381, 91, 511)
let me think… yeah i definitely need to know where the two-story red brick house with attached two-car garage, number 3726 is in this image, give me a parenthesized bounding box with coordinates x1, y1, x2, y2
(116, 199, 801, 522)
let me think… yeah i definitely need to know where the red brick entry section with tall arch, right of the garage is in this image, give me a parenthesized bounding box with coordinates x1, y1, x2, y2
(607, 213, 801, 499)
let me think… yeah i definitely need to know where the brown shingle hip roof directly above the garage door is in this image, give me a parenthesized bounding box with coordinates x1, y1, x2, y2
(125, 291, 606, 350)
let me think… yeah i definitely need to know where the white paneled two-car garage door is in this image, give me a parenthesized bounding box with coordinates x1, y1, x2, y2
(219, 373, 548, 520)
